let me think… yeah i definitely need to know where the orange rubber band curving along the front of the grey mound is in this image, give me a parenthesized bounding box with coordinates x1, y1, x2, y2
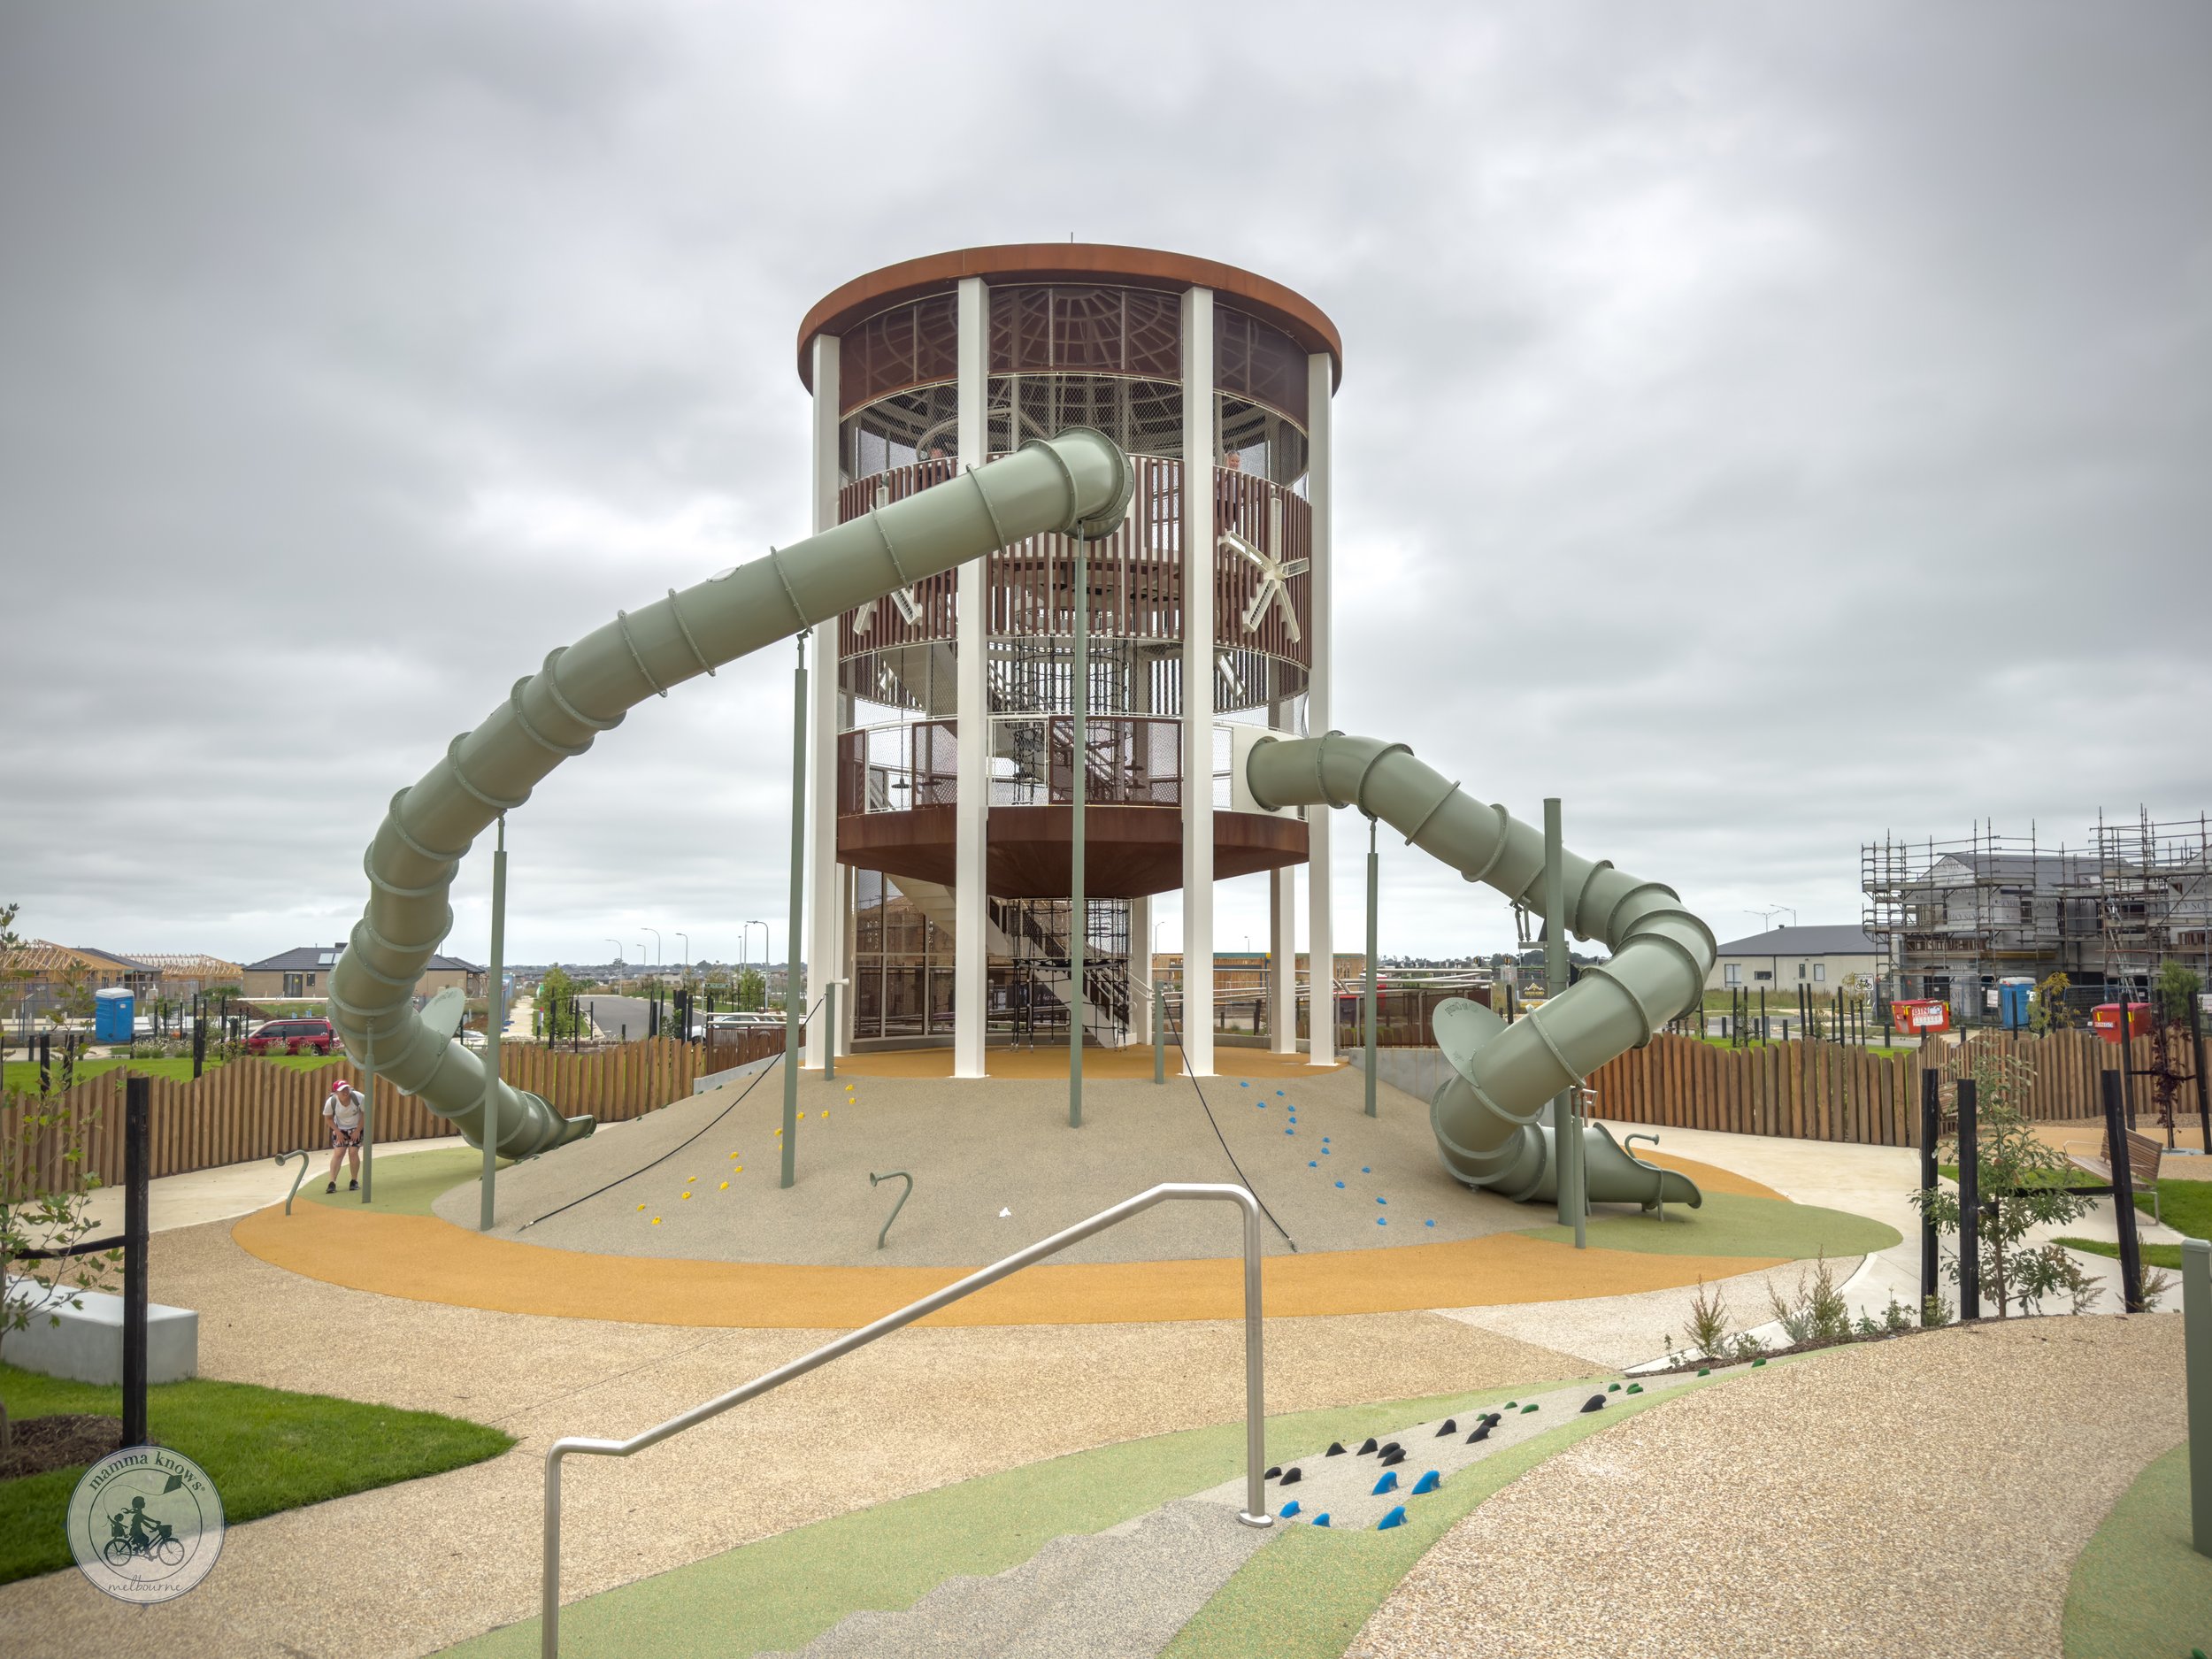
(230, 1206, 1783, 1330)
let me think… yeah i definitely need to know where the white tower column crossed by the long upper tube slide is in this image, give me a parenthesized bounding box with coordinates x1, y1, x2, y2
(954, 277, 991, 1078)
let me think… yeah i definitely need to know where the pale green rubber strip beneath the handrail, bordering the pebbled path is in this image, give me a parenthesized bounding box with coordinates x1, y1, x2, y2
(447, 1383, 1619, 1659)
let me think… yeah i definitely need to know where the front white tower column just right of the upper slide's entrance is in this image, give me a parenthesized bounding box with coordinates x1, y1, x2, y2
(1181, 288, 1215, 1078)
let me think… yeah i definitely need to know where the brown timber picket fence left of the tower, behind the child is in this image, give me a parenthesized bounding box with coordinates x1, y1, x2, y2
(0, 1031, 783, 1190)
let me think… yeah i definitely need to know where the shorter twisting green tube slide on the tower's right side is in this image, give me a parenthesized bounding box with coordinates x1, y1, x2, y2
(1246, 733, 1715, 1208)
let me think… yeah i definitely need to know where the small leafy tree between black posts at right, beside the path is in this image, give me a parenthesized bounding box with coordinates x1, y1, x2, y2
(1911, 1044, 2097, 1318)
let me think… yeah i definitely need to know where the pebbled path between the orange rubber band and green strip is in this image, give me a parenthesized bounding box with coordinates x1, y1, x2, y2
(0, 1224, 1586, 1659)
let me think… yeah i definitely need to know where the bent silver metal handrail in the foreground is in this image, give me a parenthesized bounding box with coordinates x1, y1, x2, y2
(538, 1181, 1274, 1659)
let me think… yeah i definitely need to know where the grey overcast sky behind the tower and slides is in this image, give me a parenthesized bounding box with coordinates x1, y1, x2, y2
(0, 0, 2212, 960)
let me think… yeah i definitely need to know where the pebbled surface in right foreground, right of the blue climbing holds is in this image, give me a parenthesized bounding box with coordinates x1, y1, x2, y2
(1348, 1314, 2185, 1659)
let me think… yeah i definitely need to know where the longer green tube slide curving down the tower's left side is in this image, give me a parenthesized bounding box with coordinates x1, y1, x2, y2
(330, 427, 1135, 1157)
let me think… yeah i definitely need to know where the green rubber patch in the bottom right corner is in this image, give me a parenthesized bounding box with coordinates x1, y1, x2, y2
(2062, 1440, 2212, 1659)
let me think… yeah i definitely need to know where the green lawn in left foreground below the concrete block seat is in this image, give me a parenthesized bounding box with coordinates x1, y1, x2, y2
(0, 1365, 516, 1584)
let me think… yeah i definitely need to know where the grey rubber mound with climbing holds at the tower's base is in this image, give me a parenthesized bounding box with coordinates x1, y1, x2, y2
(434, 1069, 1790, 1268)
